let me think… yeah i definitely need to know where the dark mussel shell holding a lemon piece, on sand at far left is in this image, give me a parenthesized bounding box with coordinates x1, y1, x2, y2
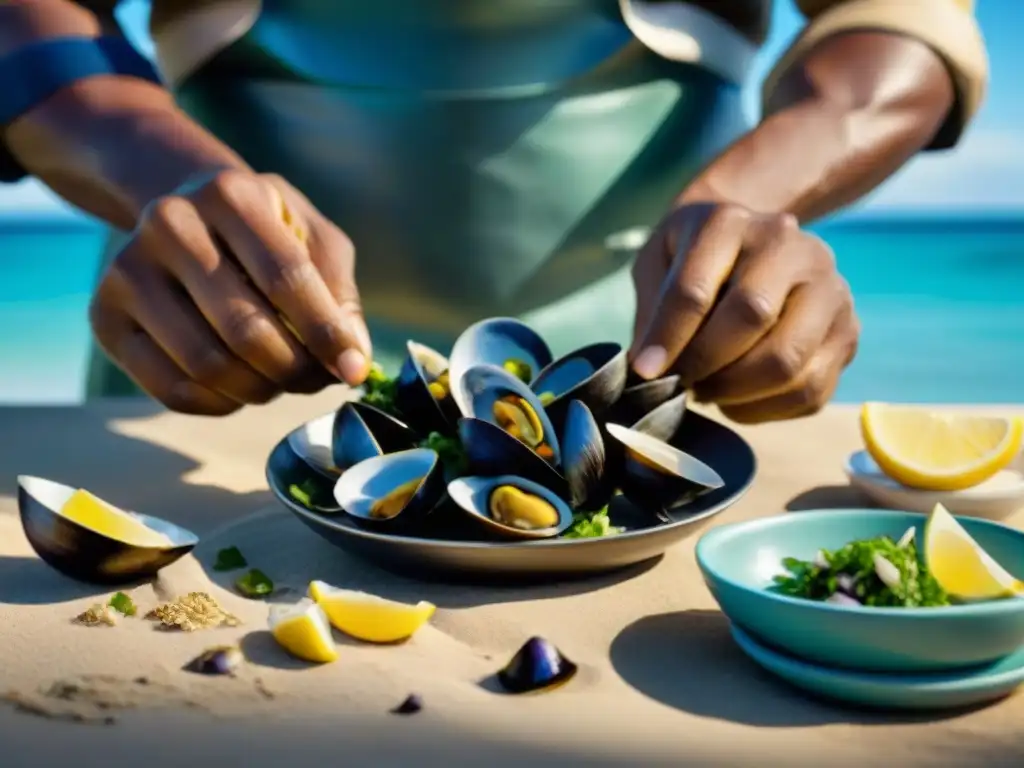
(17, 475, 199, 585)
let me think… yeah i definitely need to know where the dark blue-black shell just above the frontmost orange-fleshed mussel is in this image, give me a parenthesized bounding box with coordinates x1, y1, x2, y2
(459, 418, 568, 496)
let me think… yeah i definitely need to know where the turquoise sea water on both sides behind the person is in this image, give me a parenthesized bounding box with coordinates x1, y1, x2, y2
(0, 215, 1024, 403)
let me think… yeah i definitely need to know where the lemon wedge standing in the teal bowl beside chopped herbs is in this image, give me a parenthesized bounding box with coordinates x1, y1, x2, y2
(925, 504, 1024, 600)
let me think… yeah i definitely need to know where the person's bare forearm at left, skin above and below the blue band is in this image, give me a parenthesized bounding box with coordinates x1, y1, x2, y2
(0, 0, 245, 229)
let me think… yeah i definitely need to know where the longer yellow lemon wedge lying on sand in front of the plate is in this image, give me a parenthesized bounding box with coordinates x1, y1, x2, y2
(309, 582, 437, 643)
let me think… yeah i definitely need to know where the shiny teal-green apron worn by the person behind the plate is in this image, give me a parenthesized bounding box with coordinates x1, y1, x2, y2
(89, 0, 746, 396)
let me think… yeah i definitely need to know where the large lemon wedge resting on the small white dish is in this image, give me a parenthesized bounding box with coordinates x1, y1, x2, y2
(860, 402, 1024, 490)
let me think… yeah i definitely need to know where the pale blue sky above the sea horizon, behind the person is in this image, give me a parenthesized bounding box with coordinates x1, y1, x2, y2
(0, 0, 1024, 215)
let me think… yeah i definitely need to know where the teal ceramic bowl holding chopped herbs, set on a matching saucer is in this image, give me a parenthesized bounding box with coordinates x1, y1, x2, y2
(696, 509, 1024, 673)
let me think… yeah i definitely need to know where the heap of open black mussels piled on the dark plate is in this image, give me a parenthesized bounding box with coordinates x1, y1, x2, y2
(284, 317, 724, 540)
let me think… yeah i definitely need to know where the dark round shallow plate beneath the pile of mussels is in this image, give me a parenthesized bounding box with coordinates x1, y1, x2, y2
(266, 412, 757, 581)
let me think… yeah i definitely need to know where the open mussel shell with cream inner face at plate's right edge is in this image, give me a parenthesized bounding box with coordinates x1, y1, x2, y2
(605, 424, 725, 509)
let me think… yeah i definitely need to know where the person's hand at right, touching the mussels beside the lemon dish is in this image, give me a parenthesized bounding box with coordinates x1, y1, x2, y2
(630, 204, 859, 423)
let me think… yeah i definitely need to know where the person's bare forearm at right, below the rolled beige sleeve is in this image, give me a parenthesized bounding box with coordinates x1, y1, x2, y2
(678, 32, 955, 221)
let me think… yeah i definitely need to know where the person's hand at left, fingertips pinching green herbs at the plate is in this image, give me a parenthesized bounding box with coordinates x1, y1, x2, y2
(89, 171, 371, 416)
